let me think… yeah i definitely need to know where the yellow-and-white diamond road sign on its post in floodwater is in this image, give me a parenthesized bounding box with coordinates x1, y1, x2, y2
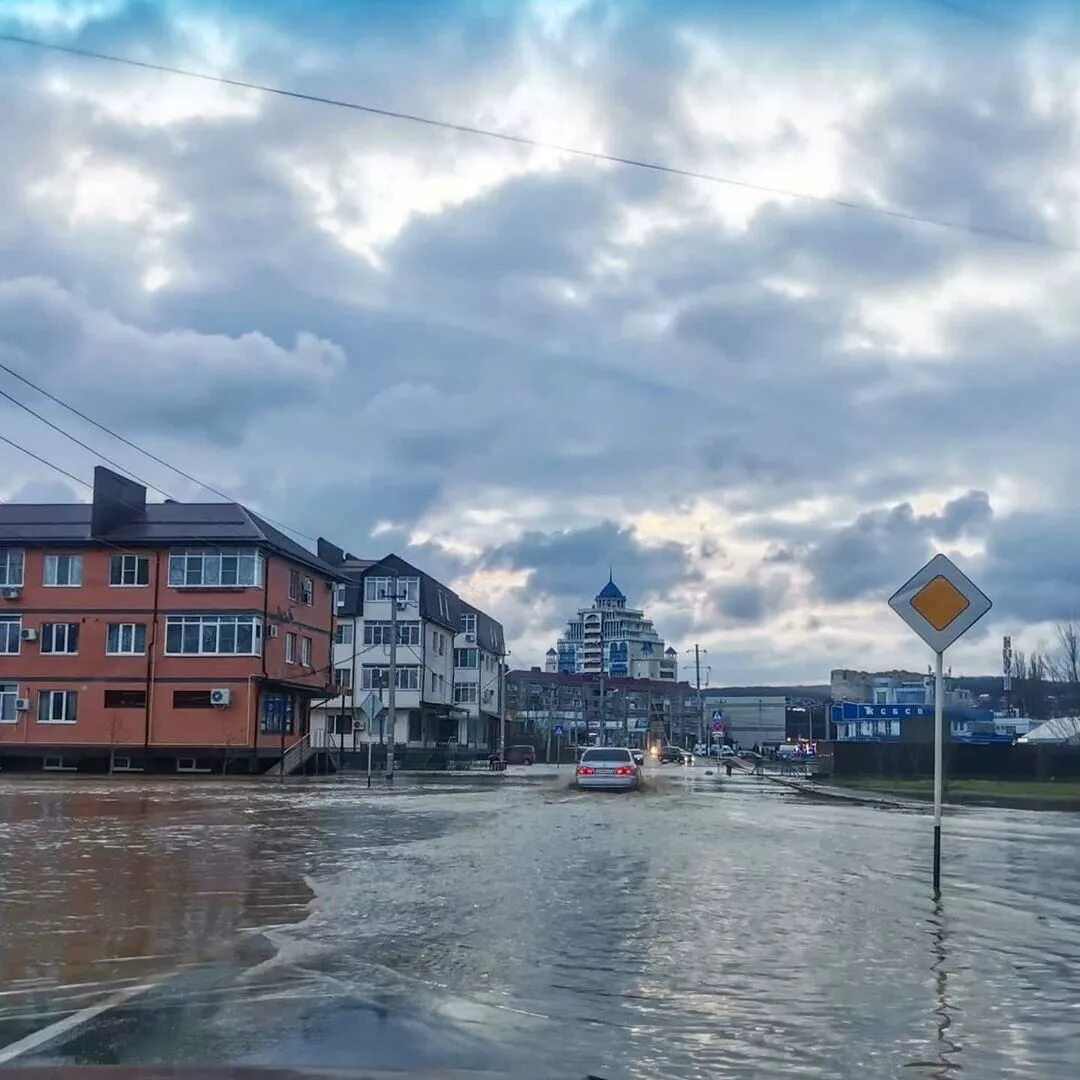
(889, 554, 991, 895)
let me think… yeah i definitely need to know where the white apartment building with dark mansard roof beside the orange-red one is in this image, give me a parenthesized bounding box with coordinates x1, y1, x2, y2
(312, 540, 505, 750)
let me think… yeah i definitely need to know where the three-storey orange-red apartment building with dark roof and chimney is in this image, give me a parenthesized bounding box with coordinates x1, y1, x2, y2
(0, 468, 339, 772)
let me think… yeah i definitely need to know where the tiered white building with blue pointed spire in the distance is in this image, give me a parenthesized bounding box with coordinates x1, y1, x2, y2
(544, 577, 678, 683)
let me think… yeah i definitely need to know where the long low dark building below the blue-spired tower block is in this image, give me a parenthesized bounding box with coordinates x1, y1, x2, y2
(507, 667, 699, 746)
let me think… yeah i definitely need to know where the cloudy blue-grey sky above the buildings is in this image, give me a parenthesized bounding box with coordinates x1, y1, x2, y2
(0, 0, 1080, 684)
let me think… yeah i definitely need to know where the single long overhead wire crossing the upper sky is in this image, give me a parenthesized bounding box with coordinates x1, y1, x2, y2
(0, 33, 1067, 252)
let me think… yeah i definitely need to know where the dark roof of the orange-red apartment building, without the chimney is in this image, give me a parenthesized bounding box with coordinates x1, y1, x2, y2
(0, 502, 339, 578)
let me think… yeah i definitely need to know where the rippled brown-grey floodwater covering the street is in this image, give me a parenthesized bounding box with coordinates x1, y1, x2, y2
(0, 770, 1080, 1080)
